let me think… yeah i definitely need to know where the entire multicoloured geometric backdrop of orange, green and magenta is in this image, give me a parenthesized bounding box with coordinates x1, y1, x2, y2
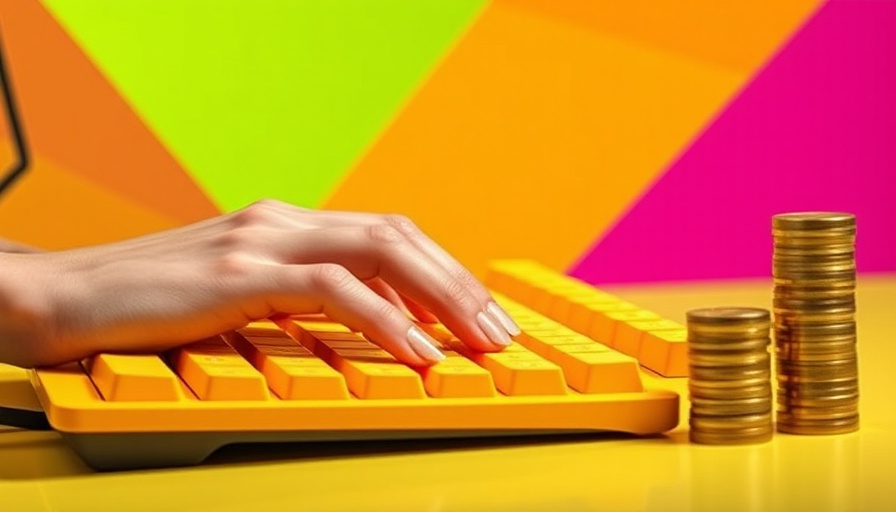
(0, 0, 896, 283)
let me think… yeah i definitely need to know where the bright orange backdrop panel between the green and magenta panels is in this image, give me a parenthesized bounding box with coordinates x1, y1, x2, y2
(325, 2, 748, 275)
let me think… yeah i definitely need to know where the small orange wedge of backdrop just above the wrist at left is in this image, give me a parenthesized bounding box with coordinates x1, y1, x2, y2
(0, 146, 179, 249)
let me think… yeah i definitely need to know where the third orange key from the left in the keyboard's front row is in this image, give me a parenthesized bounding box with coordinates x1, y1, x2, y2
(228, 331, 349, 400)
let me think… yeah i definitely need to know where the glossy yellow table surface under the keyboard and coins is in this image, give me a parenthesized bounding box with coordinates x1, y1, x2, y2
(0, 274, 896, 512)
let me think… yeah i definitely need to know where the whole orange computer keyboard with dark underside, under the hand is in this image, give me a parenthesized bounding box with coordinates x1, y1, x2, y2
(31, 261, 686, 469)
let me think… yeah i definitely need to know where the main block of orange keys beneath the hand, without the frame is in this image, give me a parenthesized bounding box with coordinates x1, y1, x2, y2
(84, 298, 643, 401)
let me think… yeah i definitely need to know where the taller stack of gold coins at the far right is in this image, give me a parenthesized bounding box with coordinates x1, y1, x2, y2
(772, 213, 859, 434)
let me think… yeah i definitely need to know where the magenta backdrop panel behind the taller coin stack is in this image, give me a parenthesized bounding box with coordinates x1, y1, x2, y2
(570, 0, 896, 283)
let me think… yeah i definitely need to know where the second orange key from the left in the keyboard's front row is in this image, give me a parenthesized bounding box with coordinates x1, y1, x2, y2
(171, 336, 271, 400)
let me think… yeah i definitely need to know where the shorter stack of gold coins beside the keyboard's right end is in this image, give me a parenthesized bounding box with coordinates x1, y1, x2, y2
(687, 308, 774, 444)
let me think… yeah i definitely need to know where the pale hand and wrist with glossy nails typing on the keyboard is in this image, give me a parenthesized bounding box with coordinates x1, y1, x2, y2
(0, 200, 519, 367)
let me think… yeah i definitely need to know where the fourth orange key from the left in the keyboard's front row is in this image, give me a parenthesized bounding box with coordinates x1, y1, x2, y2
(308, 333, 426, 399)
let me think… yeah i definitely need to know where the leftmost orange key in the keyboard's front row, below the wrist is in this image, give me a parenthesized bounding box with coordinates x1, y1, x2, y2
(85, 354, 183, 402)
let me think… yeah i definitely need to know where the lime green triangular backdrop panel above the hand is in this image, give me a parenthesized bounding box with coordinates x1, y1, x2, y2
(44, 0, 486, 210)
